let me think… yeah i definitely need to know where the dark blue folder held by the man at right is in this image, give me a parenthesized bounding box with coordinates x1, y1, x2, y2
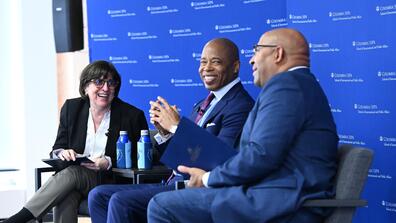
(160, 118, 237, 176)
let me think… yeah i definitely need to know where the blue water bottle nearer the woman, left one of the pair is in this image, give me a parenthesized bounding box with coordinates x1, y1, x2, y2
(117, 131, 132, 169)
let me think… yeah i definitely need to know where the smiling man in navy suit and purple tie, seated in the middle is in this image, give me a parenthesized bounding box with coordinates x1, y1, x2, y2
(88, 38, 254, 223)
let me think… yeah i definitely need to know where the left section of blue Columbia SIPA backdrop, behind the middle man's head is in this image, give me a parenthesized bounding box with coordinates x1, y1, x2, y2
(87, 0, 286, 116)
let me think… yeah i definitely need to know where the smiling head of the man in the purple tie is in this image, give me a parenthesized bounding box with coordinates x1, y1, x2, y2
(198, 40, 239, 91)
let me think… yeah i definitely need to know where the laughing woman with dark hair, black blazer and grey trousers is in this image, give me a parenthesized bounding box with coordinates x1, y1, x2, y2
(4, 61, 148, 223)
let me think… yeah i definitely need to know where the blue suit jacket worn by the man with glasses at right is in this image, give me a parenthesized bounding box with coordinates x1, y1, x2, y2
(178, 69, 338, 223)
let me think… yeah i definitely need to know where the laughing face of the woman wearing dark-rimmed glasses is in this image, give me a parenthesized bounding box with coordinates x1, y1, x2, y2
(85, 75, 116, 110)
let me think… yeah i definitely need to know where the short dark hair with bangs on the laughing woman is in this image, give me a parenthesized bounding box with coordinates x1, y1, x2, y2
(79, 60, 121, 97)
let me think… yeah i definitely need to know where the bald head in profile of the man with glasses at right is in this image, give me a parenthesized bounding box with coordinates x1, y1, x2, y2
(250, 28, 309, 87)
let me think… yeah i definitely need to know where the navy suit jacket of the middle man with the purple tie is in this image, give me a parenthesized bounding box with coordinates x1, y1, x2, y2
(190, 82, 254, 147)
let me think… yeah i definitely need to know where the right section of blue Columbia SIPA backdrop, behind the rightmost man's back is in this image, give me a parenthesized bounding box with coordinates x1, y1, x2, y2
(286, 0, 396, 223)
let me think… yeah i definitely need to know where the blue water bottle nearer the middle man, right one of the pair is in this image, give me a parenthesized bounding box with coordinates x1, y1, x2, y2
(138, 130, 153, 170)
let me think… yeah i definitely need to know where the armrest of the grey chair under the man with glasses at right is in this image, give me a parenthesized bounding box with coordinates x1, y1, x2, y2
(303, 199, 367, 208)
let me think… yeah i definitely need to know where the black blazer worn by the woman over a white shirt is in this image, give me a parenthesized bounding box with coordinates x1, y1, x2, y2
(52, 98, 148, 170)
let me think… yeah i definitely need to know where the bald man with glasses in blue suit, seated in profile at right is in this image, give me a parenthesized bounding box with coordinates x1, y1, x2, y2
(148, 28, 338, 223)
